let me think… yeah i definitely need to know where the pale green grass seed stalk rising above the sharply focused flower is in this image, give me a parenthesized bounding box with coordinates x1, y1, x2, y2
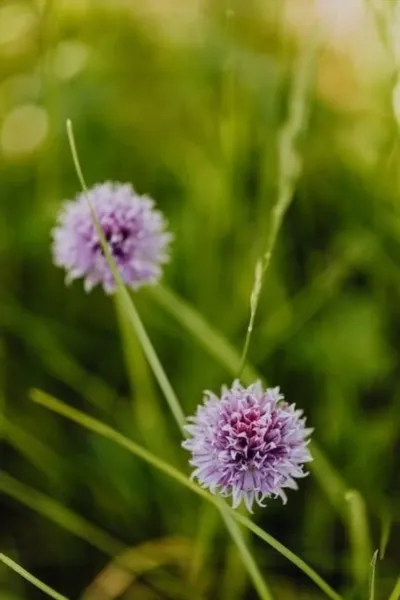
(238, 32, 318, 376)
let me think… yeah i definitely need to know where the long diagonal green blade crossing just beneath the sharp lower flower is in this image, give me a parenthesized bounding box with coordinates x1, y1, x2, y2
(31, 390, 342, 600)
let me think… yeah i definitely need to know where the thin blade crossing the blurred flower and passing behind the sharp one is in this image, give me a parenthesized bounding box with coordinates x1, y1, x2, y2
(67, 120, 271, 600)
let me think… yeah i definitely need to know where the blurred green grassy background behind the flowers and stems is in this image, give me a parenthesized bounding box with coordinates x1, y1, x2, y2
(0, 0, 400, 600)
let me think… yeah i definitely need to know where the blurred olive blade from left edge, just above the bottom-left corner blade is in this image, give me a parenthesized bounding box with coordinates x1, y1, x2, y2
(0, 471, 125, 556)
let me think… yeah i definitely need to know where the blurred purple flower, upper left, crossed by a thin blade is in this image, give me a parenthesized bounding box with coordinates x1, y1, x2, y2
(52, 182, 172, 292)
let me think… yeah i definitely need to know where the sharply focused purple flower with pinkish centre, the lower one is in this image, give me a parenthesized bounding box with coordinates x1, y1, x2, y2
(182, 381, 313, 512)
